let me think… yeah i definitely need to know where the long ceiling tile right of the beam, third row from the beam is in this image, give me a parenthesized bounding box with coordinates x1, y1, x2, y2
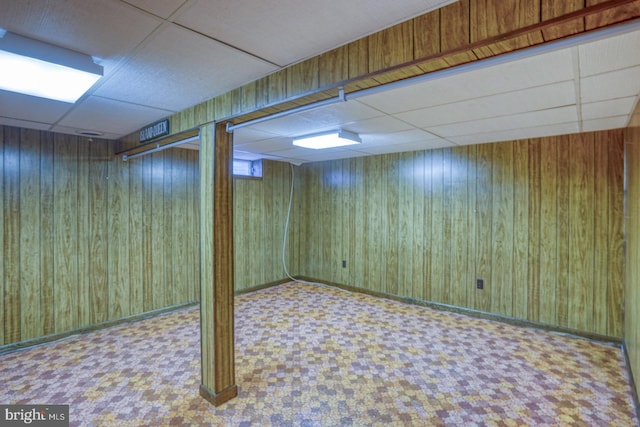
(426, 106, 578, 137)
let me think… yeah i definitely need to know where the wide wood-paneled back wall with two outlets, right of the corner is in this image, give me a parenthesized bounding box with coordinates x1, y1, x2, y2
(294, 130, 624, 338)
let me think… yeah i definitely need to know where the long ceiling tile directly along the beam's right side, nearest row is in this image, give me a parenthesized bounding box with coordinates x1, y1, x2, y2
(357, 50, 573, 114)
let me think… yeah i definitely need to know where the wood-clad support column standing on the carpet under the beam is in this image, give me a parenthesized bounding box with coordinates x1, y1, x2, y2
(200, 123, 238, 406)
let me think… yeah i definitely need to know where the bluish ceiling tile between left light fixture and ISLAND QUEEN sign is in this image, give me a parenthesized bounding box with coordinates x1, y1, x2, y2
(58, 96, 171, 136)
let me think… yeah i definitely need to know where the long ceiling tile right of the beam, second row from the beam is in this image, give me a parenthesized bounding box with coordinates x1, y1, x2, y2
(396, 81, 576, 128)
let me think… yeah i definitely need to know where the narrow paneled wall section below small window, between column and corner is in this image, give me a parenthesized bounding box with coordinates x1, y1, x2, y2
(233, 160, 299, 291)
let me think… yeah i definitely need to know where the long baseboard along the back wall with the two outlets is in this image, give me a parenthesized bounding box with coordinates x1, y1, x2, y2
(295, 276, 622, 347)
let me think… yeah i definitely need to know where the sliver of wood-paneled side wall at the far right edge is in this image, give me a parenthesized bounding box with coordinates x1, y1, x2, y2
(624, 104, 640, 402)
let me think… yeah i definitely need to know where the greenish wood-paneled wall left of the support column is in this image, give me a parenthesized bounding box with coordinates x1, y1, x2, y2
(0, 126, 199, 345)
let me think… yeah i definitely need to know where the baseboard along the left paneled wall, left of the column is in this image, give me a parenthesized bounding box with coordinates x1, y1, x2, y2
(0, 301, 200, 355)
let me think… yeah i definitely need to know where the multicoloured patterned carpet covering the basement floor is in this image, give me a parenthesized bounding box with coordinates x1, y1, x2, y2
(0, 283, 638, 426)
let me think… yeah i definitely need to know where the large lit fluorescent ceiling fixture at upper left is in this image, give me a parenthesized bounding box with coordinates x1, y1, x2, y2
(0, 31, 103, 103)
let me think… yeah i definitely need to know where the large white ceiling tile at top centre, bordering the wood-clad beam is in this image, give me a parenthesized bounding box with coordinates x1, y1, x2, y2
(176, 0, 453, 66)
